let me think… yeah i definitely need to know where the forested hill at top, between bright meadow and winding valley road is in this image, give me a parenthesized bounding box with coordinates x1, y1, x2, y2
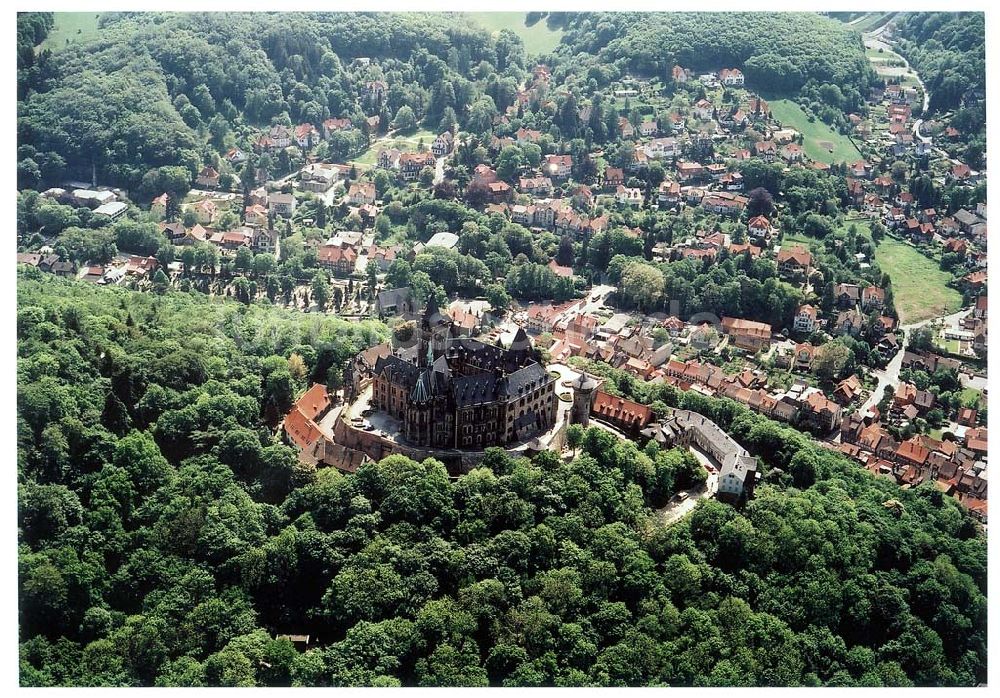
(559, 12, 873, 94)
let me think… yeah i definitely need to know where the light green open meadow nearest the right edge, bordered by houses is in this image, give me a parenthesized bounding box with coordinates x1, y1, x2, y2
(875, 238, 962, 325)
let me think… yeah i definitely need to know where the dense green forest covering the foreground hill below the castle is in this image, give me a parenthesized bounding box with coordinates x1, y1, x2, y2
(17, 271, 987, 686)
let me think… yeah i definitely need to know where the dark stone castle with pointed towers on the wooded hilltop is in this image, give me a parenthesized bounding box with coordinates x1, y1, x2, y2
(355, 300, 558, 450)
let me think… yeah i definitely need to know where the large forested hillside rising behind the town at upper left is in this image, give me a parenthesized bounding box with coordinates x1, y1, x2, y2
(18, 13, 525, 186)
